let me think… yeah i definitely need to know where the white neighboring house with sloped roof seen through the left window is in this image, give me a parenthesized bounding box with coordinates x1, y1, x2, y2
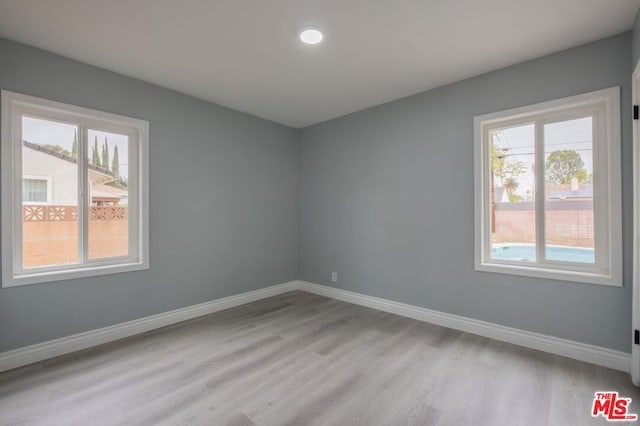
(22, 141, 128, 206)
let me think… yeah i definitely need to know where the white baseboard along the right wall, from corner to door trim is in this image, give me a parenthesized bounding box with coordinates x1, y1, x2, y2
(297, 281, 631, 373)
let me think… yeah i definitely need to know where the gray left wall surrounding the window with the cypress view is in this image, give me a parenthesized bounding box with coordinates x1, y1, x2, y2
(0, 39, 298, 352)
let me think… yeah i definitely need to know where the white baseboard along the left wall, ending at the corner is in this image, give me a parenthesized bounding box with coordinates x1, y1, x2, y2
(0, 281, 299, 372)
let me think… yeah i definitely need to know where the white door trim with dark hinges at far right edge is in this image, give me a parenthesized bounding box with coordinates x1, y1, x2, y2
(629, 61, 640, 386)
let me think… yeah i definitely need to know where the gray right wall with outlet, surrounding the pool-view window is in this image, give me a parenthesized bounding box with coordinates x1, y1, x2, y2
(299, 33, 632, 352)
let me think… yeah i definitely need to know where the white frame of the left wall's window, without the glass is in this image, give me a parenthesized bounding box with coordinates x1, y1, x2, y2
(0, 90, 149, 287)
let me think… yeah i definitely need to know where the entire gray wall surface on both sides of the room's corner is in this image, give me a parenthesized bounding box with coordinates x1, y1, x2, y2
(0, 31, 640, 352)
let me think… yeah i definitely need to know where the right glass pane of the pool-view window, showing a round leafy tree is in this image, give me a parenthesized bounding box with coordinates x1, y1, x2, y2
(544, 117, 595, 263)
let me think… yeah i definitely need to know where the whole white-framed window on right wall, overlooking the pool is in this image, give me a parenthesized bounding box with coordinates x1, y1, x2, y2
(474, 87, 622, 286)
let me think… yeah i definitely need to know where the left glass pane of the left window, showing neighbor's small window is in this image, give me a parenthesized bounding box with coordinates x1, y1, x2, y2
(22, 116, 78, 268)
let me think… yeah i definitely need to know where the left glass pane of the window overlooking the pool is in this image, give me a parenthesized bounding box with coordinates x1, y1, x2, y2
(489, 124, 536, 261)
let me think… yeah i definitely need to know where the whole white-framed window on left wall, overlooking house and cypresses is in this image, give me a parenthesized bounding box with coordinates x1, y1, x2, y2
(1, 91, 149, 287)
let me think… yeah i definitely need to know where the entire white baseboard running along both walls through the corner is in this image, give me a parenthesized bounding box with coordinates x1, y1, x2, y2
(0, 281, 631, 372)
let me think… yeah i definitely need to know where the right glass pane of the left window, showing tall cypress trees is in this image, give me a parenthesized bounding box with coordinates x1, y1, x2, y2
(88, 130, 129, 259)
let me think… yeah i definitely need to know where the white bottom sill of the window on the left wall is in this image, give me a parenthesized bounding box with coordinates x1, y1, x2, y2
(2, 262, 149, 288)
